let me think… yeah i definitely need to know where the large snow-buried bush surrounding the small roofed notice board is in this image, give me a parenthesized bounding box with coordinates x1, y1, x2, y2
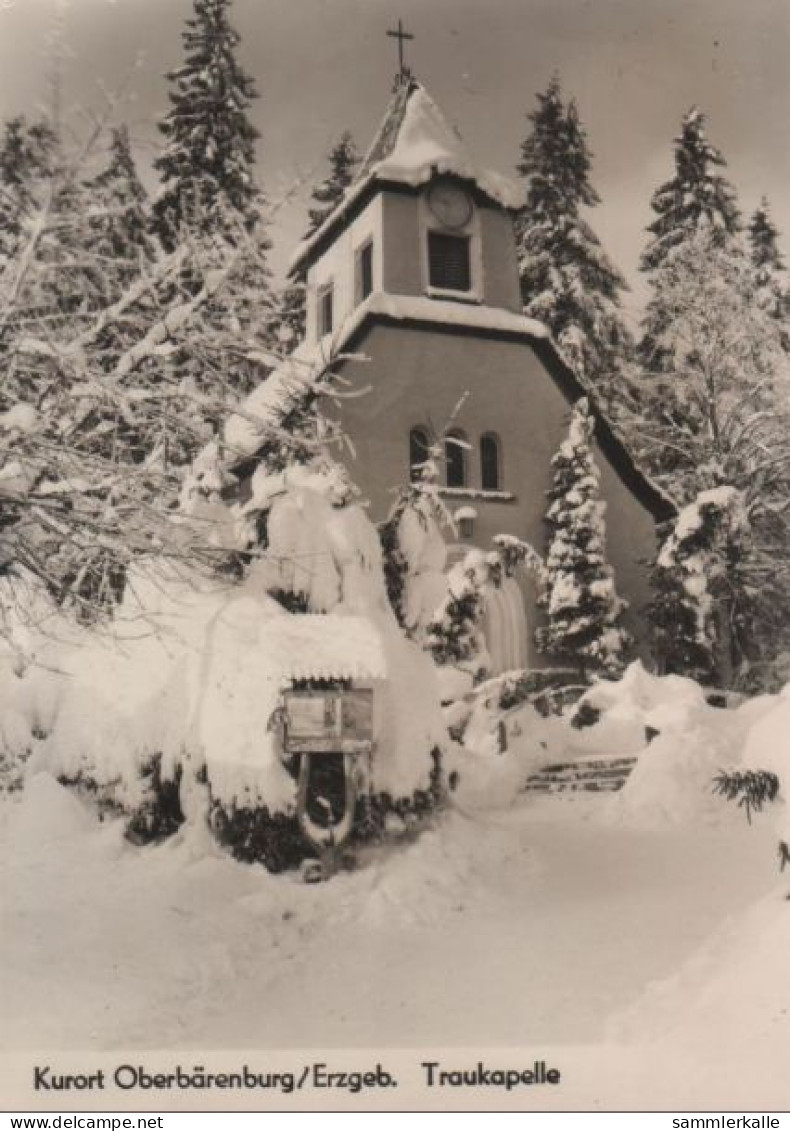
(19, 499, 445, 867)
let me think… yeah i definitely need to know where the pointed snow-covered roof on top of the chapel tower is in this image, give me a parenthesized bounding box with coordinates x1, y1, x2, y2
(290, 79, 523, 271)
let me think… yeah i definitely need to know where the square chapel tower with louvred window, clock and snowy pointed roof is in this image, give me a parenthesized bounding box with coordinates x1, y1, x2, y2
(292, 78, 521, 343)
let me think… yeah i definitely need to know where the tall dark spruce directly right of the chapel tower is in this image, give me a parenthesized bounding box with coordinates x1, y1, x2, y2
(516, 76, 632, 407)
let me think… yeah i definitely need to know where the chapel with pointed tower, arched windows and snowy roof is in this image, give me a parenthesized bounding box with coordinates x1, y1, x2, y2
(230, 77, 671, 671)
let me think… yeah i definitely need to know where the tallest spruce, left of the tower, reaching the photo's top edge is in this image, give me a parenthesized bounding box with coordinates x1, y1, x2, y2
(153, 0, 276, 402)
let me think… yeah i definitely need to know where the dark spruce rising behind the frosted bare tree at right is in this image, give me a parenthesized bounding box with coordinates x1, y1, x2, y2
(639, 106, 740, 372)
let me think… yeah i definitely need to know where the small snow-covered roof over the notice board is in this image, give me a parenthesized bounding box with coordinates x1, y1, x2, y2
(261, 613, 387, 680)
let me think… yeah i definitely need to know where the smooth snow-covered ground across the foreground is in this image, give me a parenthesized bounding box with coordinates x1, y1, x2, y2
(0, 775, 774, 1051)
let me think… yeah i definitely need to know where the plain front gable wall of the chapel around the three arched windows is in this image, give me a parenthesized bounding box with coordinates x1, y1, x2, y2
(332, 325, 654, 662)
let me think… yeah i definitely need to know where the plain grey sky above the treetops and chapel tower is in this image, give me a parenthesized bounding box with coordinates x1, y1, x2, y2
(0, 0, 790, 327)
